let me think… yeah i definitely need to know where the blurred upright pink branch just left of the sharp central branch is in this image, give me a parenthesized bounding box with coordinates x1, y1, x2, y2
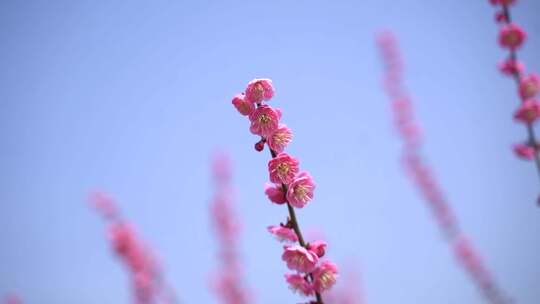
(210, 154, 254, 304)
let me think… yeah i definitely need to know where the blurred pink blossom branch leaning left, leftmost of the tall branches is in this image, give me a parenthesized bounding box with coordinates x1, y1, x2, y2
(90, 192, 178, 304)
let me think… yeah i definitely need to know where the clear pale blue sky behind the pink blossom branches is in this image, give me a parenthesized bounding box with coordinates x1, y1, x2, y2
(0, 0, 540, 304)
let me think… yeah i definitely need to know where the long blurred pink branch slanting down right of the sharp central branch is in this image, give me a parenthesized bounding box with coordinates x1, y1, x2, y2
(377, 32, 510, 304)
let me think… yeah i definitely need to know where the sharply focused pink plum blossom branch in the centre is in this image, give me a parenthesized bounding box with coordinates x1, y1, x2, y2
(232, 79, 338, 304)
